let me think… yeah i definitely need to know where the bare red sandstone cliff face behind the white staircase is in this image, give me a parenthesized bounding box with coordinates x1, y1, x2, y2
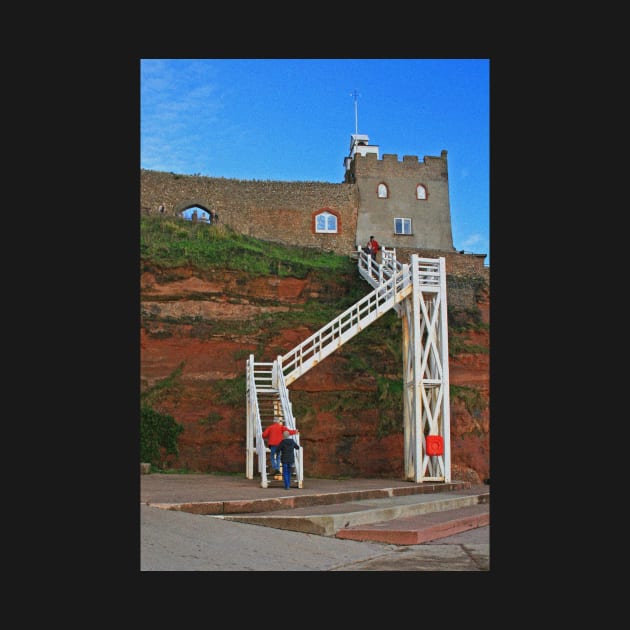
(140, 268, 490, 483)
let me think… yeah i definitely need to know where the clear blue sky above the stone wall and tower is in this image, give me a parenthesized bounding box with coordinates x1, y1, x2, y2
(140, 59, 490, 265)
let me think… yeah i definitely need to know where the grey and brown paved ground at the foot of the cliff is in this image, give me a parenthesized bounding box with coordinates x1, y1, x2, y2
(140, 473, 490, 571)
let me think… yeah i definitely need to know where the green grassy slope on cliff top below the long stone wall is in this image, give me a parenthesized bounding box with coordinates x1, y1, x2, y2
(140, 216, 356, 278)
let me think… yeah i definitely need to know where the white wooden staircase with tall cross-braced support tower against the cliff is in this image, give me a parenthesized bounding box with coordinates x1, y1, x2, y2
(246, 248, 450, 488)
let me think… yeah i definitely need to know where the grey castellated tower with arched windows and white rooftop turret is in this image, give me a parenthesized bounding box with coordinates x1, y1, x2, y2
(344, 134, 455, 252)
